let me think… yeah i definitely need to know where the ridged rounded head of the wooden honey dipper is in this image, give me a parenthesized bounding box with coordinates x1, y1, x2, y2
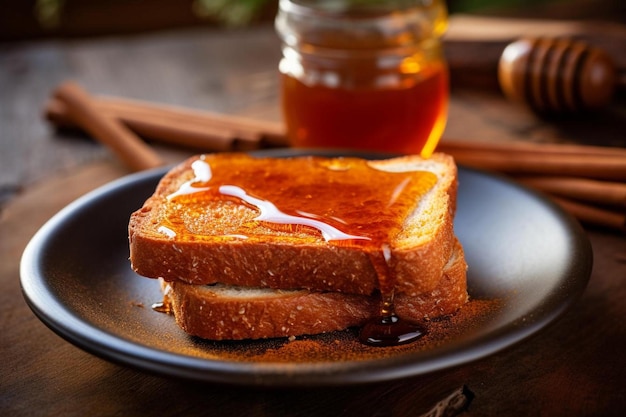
(498, 38, 618, 113)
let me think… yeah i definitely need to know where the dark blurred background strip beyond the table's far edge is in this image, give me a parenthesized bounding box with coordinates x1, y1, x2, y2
(0, 0, 626, 41)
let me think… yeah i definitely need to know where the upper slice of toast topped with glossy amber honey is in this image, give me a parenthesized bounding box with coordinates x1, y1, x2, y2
(129, 153, 457, 297)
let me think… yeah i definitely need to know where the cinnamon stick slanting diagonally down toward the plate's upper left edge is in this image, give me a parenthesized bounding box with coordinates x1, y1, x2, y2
(54, 82, 163, 171)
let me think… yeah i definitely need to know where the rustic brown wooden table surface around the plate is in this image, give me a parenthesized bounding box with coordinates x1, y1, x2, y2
(0, 15, 626, 416)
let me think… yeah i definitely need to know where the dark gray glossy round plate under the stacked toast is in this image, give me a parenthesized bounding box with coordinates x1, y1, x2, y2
(21, 151, 592, 386)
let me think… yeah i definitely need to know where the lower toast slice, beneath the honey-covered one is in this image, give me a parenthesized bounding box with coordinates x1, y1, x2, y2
(162, 242, 468, 340)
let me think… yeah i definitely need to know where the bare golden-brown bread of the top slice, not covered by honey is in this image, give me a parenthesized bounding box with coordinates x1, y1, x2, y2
(129, 154, 457, 297)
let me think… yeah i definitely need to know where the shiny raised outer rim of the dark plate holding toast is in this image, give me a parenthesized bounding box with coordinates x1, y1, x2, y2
(20, 150, 593, 386)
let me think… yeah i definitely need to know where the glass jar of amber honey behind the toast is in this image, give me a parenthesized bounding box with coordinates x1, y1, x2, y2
(275, 0, 449, 157)
